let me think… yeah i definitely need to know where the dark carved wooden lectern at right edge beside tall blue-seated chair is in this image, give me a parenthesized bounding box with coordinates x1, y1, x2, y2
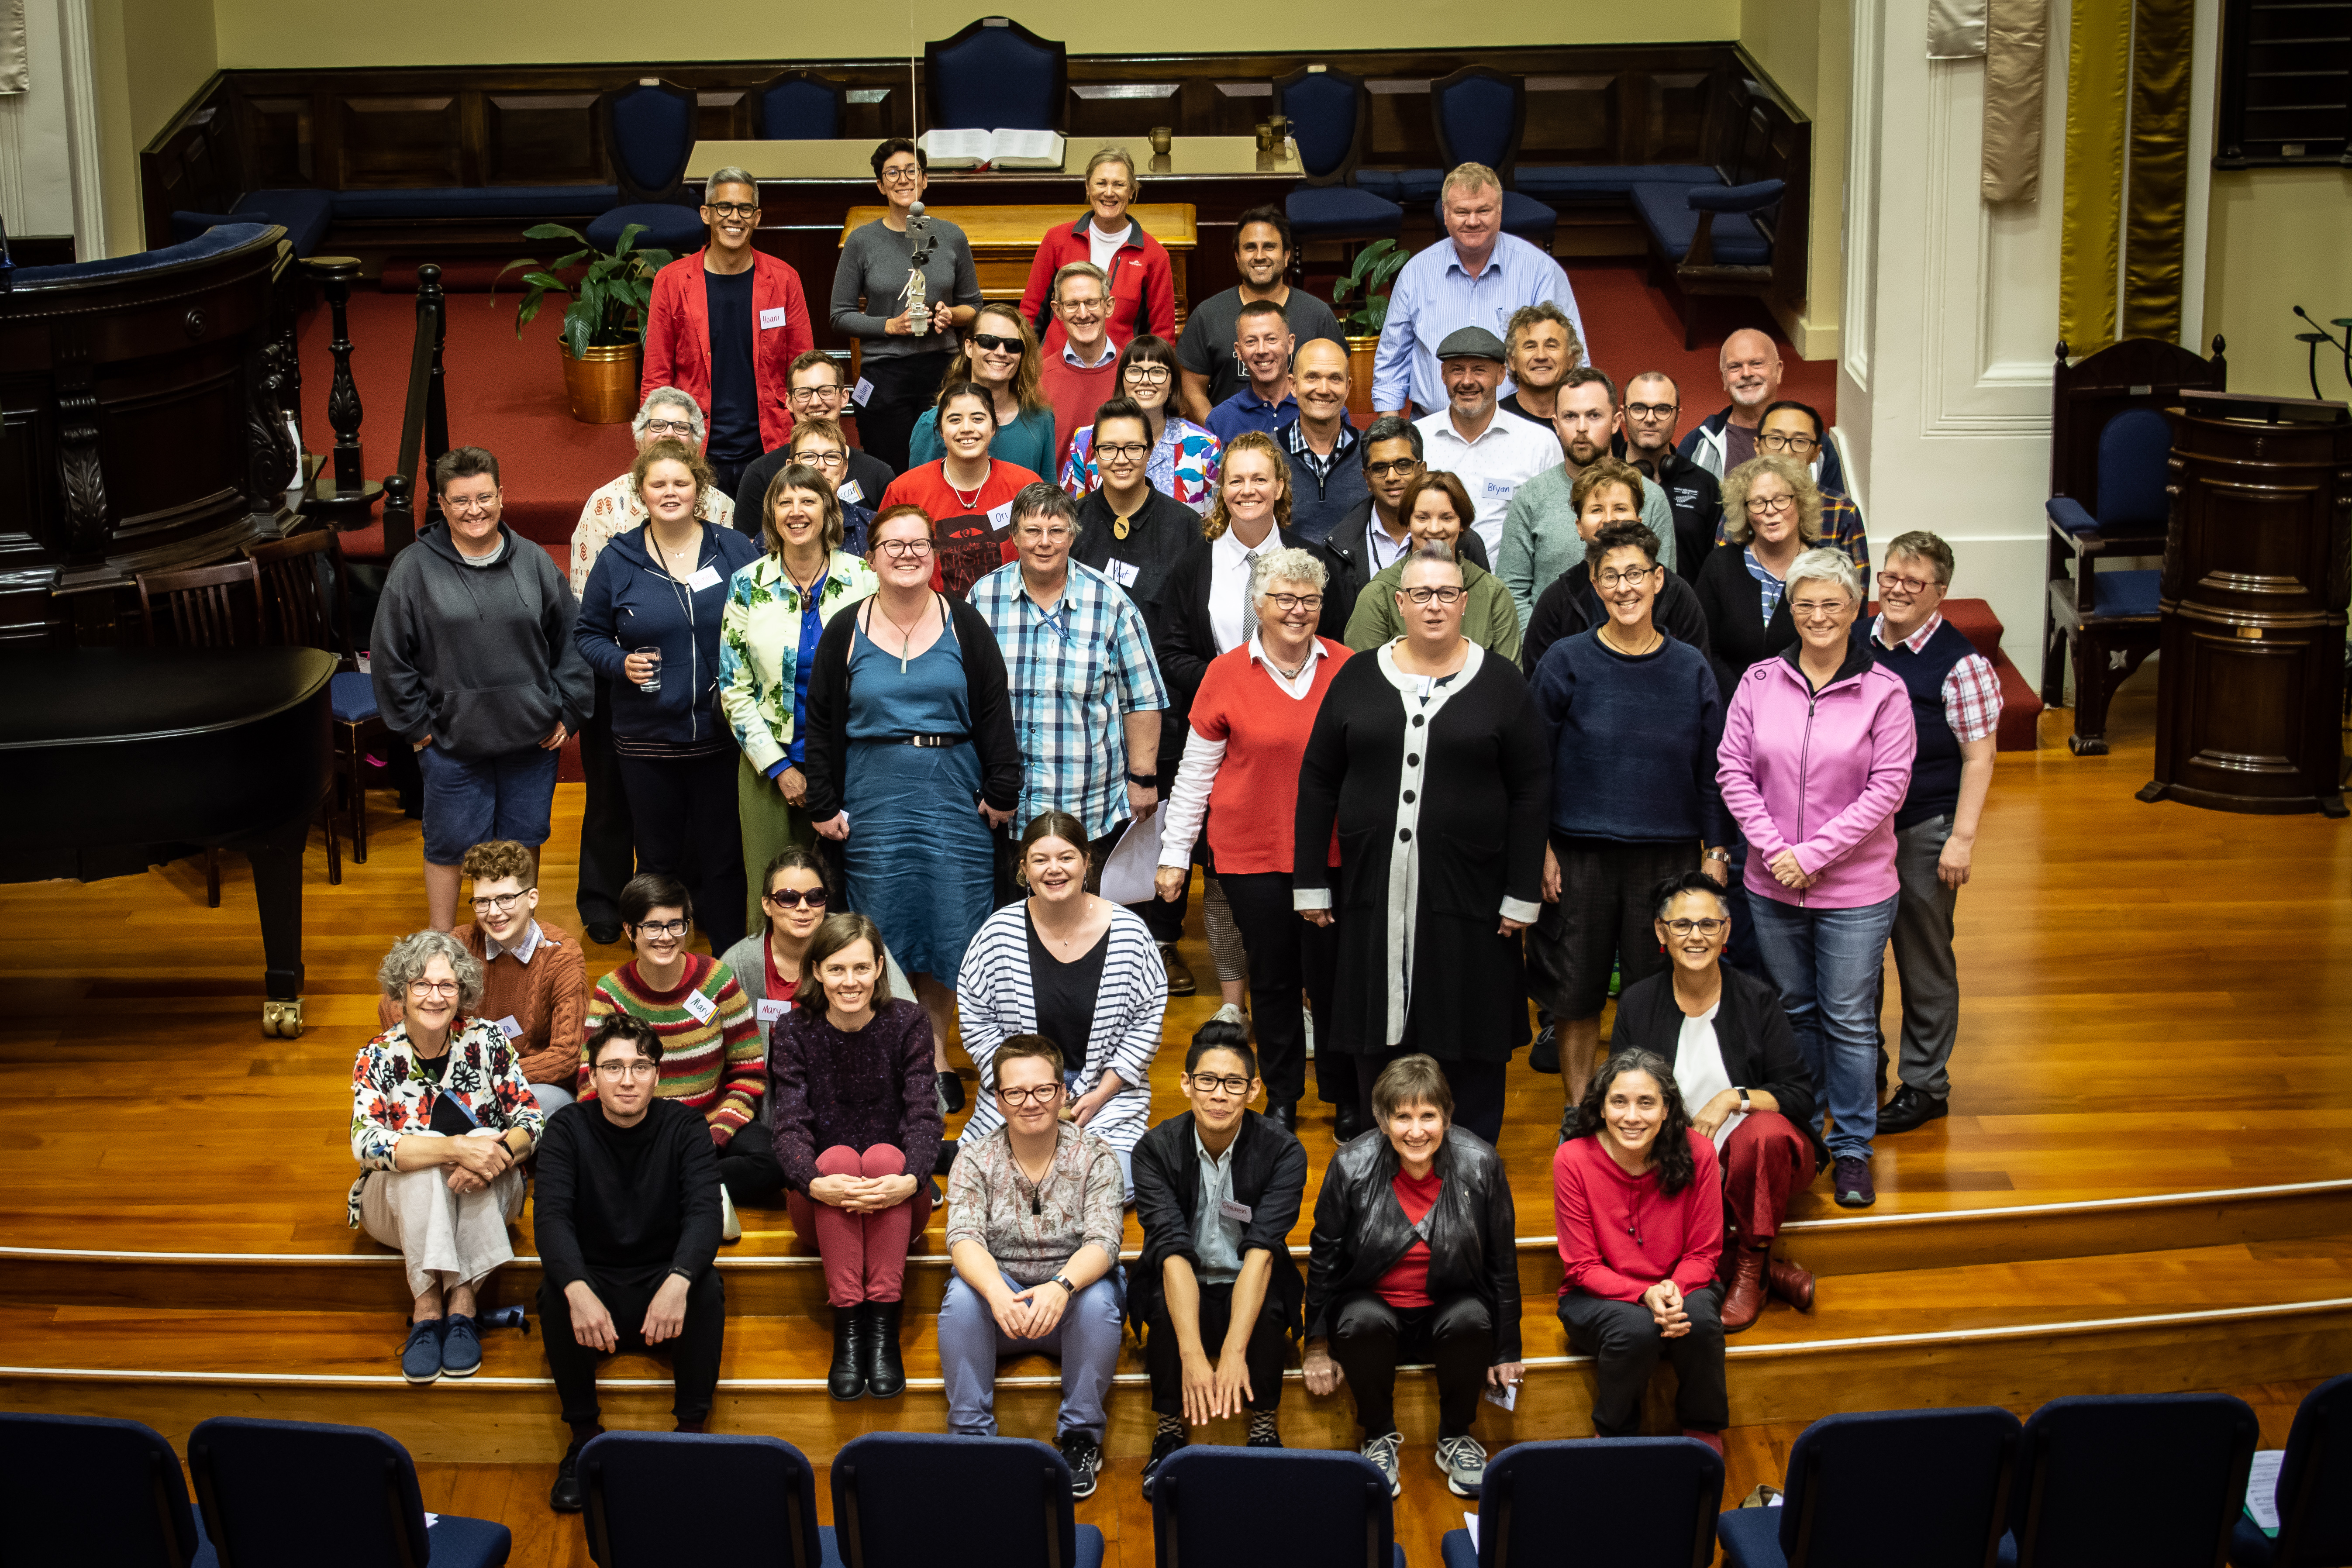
(2140, 393, 2352, 816)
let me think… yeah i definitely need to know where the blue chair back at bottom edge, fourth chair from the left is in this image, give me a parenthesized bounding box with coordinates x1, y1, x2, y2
(833, 1432, 1103, 1568)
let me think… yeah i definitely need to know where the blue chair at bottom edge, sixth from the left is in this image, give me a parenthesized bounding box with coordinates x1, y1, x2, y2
(1437, 1437, 1724, 1568)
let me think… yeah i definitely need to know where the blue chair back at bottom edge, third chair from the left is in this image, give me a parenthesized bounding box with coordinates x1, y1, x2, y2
(581, 1432, 842, 1568)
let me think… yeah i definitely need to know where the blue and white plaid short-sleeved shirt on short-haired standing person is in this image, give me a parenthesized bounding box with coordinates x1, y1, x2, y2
(971, 562, 1169, 839)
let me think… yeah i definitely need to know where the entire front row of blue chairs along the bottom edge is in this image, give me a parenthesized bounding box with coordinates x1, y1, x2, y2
(0, 1375, 2352, 1568)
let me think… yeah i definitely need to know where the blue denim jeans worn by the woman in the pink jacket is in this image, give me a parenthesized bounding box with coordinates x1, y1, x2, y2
(1748, 896, 1896, 1159)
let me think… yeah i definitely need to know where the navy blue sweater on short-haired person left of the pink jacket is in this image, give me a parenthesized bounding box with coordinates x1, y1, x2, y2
(1536, 627, 1731, 844)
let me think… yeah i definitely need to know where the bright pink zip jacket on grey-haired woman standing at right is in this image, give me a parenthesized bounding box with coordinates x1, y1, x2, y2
(1717, 649, 1919, 910)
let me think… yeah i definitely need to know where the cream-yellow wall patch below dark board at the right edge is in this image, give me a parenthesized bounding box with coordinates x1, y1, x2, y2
(2204, 169, 2352, 400)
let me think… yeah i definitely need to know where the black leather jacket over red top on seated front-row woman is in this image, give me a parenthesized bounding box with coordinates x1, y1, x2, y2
(1305, 1126, 1519, 1366)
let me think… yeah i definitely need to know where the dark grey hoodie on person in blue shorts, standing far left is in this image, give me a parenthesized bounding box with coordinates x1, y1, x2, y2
(369, 524, 595, 762)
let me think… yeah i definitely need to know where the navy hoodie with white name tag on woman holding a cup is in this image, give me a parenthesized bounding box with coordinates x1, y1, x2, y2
(576, 522, 760, 745)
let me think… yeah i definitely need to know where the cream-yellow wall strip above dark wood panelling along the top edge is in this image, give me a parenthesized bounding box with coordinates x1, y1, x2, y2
(207, 0, 1741, 68)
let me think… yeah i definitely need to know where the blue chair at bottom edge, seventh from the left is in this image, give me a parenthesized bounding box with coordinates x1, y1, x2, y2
(1714, 1406, 2018, 1568)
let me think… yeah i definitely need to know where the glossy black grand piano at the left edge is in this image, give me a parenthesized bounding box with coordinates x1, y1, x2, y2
(0, 647, 334, 1039)
